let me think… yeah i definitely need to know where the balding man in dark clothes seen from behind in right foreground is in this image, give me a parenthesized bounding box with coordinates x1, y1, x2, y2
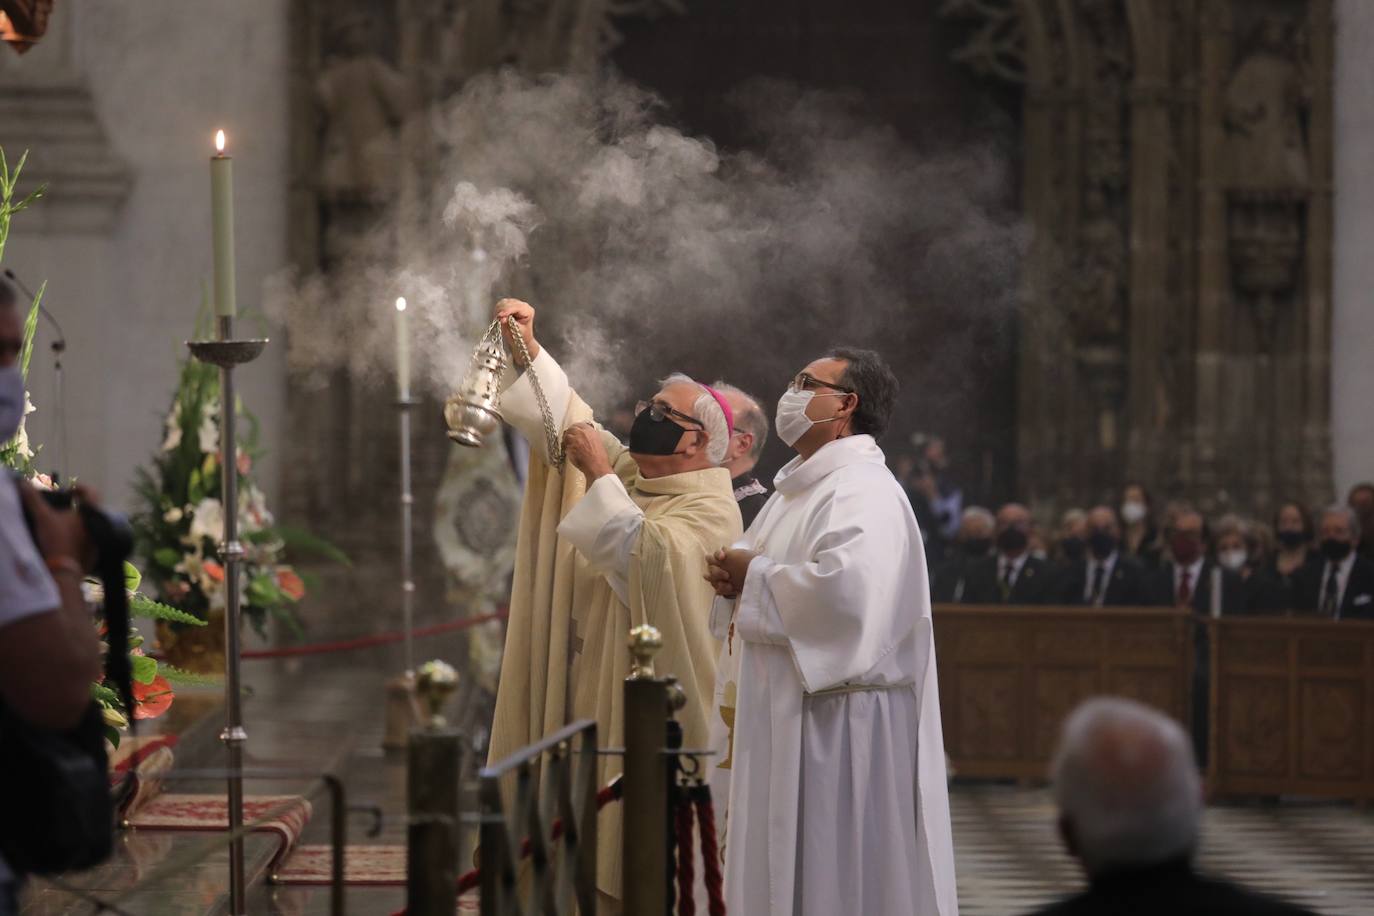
(1036, 696, 1311, 916)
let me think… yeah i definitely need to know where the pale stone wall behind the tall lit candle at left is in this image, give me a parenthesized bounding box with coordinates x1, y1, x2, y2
(0, 0, 289, 508)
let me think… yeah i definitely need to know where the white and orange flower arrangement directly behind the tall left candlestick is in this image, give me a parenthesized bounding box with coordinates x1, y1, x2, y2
(133, 307, 348, 645)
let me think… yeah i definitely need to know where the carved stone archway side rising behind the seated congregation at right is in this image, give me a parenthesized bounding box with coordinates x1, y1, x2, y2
(943, 0, 1333, 512)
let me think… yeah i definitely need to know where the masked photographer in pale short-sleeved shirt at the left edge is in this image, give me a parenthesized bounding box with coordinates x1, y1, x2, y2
(0, 279, 100, 916)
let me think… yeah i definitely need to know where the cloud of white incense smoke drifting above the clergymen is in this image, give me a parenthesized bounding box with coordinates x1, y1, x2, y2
(271, 71, 1025, 422)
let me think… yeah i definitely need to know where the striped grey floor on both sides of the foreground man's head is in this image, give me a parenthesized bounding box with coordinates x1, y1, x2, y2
(949, 784, 1374, 916)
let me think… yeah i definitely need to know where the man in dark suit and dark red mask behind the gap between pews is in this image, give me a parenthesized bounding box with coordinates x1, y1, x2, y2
(1151, 505, 1245, 765)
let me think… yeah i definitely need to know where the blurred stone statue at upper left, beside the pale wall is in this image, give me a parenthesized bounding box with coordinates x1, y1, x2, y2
(315, 14, 409, 201)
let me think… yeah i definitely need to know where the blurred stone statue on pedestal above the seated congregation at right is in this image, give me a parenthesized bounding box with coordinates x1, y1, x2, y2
(1226, 16, 1309, 190)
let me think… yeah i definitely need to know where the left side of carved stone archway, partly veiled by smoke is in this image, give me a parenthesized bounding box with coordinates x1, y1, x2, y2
(283, 0, 682, 634)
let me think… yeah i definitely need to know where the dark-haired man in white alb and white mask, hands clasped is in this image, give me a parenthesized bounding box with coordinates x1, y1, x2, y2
(708, 349, 959, 916)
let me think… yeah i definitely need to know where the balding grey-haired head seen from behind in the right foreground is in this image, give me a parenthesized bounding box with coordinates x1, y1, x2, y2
(1050, 696, 1202, 875)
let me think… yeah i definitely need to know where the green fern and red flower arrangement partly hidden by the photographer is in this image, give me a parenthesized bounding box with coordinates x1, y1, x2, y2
(0, 150, 206, 746)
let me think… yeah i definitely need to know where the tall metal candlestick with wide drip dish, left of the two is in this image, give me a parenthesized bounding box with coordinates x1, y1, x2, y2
(187, 317, 267, 916)
